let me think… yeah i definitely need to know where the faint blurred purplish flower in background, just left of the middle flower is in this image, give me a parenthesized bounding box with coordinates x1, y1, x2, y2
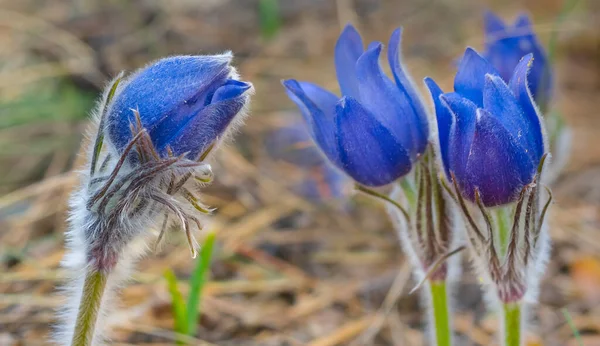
(265, 121, 350, 202)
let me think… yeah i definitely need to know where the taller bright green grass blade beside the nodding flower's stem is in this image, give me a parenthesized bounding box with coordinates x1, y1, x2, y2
(187, 233, 215, 335)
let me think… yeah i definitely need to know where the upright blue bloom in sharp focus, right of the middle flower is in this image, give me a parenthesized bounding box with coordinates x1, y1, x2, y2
(425, 48, 544, 206)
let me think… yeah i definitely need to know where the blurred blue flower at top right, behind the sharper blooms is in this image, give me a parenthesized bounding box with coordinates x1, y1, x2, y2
(483, 12, 552, 109)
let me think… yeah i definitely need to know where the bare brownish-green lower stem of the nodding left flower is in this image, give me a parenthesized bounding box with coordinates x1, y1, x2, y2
(71, 270, 108, 346)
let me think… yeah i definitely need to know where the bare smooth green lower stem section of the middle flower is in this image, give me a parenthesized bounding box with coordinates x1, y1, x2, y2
(430, 281, 452, 346)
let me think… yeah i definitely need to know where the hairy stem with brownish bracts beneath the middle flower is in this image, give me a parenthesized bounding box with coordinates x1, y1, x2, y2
(380, 149, 464, 346)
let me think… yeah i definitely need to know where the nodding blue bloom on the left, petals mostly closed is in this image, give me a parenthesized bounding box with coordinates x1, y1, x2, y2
(107, 54, 252, 159)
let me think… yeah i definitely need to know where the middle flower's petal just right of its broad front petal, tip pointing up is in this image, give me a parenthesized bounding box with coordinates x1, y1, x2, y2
(356, 43, 418, 159)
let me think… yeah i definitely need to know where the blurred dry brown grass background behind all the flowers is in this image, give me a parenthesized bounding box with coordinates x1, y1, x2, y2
(0, 0, 600, 346)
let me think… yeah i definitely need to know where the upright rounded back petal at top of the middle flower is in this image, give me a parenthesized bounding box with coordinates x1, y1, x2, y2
(335, 24, 363, 98)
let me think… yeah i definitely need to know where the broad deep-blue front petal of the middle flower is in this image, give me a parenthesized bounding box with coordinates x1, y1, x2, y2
(336, 97, 412, 186)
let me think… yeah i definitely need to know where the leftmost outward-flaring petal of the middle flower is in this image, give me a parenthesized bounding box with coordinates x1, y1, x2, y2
(283, 79, 339, 163)
